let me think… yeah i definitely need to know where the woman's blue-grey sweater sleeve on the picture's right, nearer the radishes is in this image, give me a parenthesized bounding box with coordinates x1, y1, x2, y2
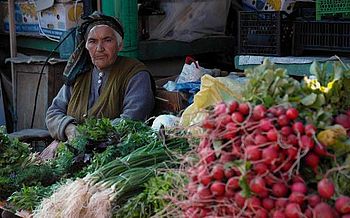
(117, 71, 154, 121)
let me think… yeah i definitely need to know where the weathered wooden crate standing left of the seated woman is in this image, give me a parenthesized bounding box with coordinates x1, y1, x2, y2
(15, 62, 66, 130)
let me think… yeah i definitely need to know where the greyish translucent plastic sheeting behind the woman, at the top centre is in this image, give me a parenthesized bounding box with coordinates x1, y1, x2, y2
(150, 0, 231, 42)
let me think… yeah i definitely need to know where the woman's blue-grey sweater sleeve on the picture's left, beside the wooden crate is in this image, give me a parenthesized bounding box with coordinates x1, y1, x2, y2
(45, 85, 75, 141)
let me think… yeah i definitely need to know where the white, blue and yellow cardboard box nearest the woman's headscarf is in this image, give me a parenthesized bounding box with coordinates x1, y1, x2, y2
(39, 2, 83, 39)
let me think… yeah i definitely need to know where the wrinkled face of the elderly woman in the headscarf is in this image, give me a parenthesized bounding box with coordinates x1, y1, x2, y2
(85, 25, 122, 70)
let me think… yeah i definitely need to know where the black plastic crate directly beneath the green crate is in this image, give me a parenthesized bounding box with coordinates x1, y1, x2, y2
(293, 21, 350, 55)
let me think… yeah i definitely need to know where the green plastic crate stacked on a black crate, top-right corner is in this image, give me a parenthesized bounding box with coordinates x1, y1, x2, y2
(316, 0, 350, 21)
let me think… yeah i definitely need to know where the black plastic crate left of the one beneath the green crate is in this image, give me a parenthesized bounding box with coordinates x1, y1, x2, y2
(239, 11, 293, 56)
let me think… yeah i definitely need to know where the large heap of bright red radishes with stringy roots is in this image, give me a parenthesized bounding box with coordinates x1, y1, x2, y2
(182, 101, 350, 218)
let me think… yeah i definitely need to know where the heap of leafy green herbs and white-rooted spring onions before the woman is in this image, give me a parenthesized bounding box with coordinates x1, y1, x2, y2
(0, 119, 188, 217)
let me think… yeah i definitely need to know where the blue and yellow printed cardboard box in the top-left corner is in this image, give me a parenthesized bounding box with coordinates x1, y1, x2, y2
(0, 1, 39, 35)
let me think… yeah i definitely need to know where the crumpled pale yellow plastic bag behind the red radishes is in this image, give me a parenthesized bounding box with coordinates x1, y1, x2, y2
(180, 75, 244, 126)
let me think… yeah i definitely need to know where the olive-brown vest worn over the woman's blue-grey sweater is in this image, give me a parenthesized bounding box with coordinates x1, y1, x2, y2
(67, 56, 148, 123)
